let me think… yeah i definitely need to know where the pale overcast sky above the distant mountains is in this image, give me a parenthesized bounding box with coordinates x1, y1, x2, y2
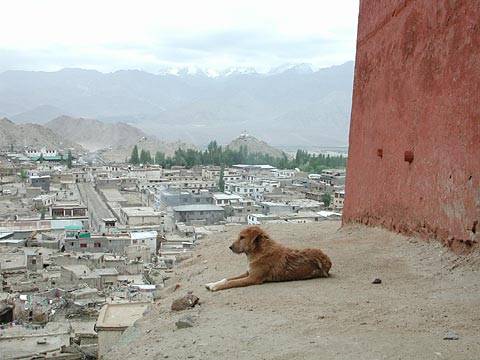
(0, 0, 358, 73)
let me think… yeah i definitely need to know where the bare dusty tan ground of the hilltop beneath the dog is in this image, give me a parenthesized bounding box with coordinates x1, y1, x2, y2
(106, 221, 480, 360)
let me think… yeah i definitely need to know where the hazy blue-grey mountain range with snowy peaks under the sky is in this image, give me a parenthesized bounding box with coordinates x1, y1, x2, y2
(0, 62, 353, 147)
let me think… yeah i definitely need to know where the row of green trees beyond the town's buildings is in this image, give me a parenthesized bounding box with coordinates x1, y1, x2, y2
(129, 141, 347, 173)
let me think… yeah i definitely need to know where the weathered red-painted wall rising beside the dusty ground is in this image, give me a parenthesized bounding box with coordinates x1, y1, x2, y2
(344, 0, 480, 250)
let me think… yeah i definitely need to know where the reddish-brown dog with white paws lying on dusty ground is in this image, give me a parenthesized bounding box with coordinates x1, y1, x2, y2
(205, 226, 332, 291)
